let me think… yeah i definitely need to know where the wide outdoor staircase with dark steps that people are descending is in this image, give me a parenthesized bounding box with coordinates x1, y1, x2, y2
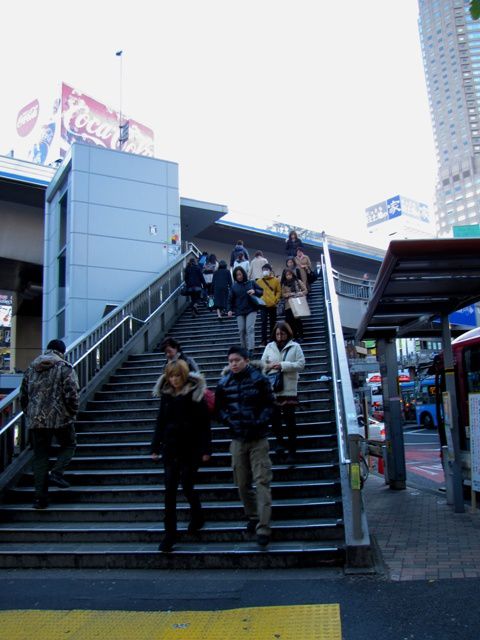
(0, 282, 344, 569)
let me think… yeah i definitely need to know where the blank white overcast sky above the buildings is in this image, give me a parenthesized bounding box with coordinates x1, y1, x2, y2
(0, 0, 436, 244)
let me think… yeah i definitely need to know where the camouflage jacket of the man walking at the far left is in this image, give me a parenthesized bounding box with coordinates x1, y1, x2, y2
(20, 350, 79, 429)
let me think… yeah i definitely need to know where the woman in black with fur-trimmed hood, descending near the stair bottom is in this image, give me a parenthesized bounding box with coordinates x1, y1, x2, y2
(151, 360, 211, 551)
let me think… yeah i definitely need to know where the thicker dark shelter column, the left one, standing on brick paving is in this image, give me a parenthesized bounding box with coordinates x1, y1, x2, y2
(377, 338, 407, 489)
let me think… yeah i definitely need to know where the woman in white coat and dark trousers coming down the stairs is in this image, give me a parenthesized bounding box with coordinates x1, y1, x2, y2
(262, 322, 305, 463)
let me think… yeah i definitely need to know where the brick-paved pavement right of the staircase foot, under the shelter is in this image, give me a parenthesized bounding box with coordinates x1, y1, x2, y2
(364, 474, 480, 580)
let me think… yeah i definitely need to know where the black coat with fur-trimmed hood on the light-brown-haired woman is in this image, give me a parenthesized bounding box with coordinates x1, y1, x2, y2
(151, 373, 211, 462)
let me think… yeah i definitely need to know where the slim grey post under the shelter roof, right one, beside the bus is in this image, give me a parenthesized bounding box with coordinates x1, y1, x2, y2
(442, 314, 465, 513)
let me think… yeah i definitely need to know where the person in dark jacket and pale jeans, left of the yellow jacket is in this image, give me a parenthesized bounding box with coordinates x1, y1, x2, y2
(228, 267, 263, 356)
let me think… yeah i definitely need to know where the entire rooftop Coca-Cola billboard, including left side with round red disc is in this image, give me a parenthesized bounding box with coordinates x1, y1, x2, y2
(14, 83, 154, 165)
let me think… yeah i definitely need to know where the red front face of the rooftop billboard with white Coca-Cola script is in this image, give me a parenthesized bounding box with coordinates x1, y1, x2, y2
(60, 84, 154, 157)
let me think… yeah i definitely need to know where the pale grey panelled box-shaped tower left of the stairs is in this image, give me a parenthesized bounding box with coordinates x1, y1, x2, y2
(43, 145, 181, 343)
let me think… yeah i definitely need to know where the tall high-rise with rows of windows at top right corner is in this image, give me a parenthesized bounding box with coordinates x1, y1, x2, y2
(418, 0, 480, 237)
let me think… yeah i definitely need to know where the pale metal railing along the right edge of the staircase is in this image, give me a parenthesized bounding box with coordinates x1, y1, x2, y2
(322, 233, 371, 566)
